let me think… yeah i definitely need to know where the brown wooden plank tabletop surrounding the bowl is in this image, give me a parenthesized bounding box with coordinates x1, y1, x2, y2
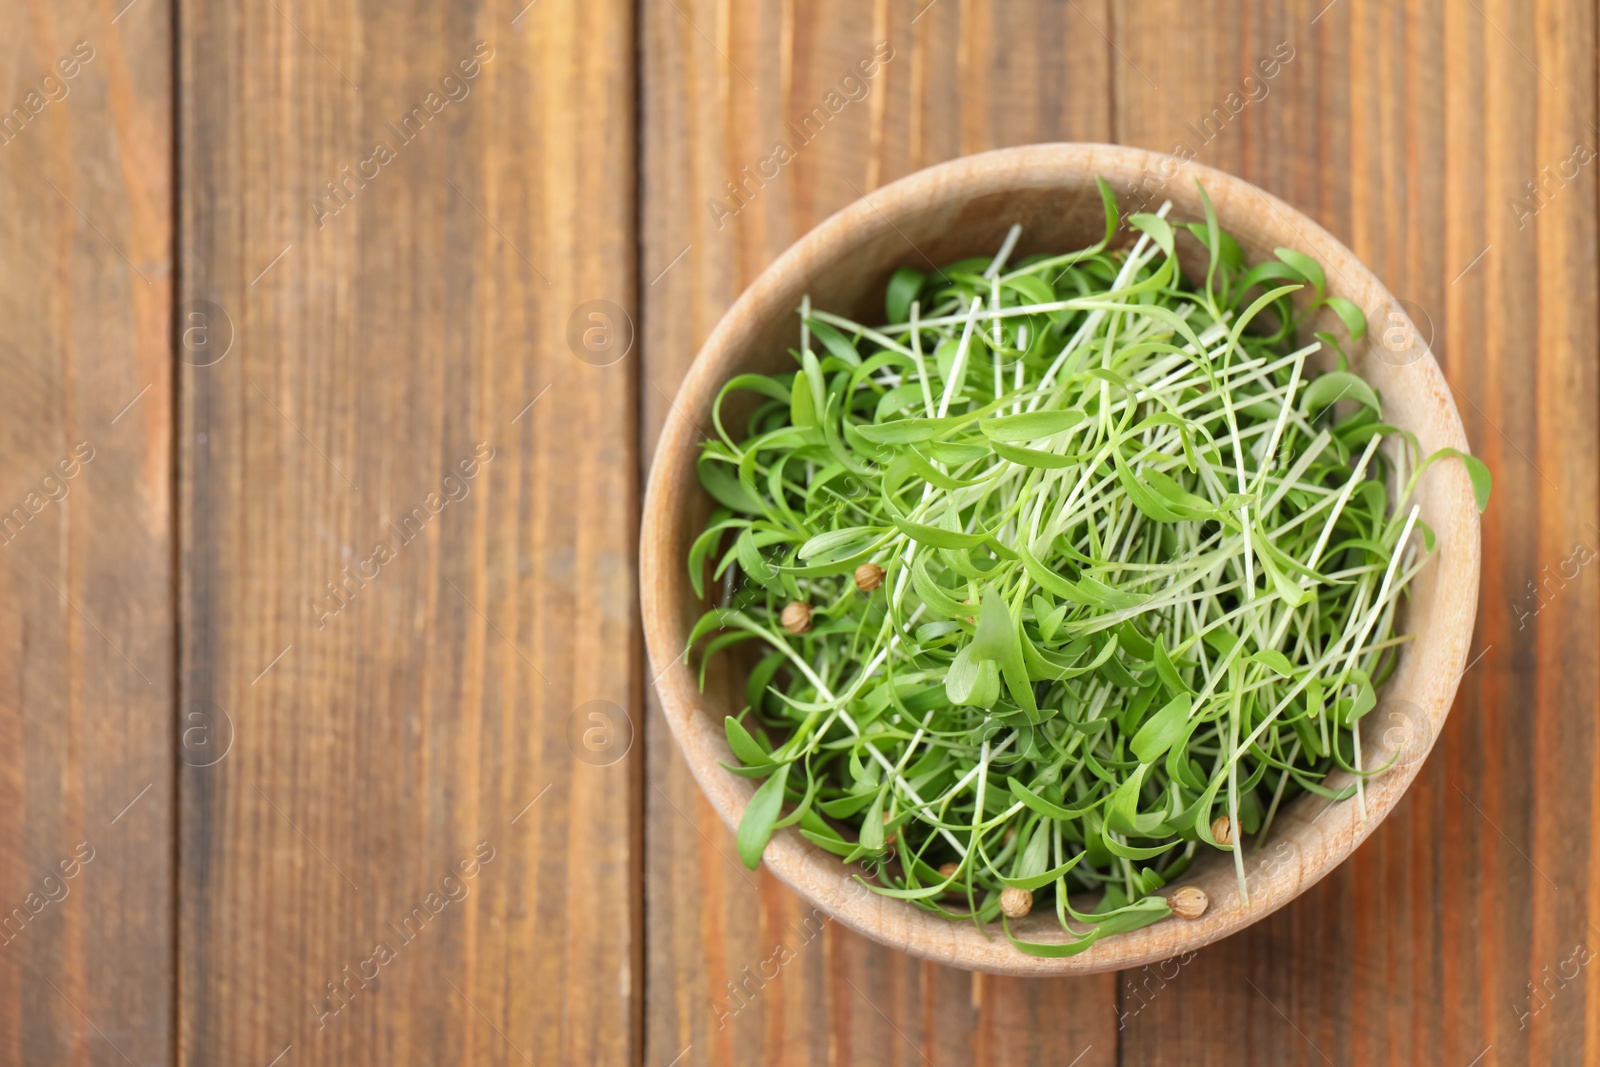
(0, 0, 1600, 1067)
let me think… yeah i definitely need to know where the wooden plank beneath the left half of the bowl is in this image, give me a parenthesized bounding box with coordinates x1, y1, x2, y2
(640, 0, 1117, 1067)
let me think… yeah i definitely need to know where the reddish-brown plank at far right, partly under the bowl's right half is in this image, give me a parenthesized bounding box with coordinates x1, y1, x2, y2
(1117, 0, 1600, 1064)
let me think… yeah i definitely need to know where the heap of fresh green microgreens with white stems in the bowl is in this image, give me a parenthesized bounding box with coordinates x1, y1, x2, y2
(688, 182, 1488, 955)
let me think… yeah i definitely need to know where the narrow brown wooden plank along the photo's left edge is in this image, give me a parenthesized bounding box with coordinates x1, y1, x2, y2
(0, 0, 174, 1064)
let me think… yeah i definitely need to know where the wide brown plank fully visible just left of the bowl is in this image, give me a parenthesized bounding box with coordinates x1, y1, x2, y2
(179, 0, 642, 1067)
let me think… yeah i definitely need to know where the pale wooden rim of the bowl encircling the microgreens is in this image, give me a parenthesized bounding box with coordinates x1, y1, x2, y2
(640, 142, 1480, 976)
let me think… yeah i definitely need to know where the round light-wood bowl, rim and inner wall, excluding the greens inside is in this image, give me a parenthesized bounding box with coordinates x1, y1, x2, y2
(640, 144, 1478, 976)
